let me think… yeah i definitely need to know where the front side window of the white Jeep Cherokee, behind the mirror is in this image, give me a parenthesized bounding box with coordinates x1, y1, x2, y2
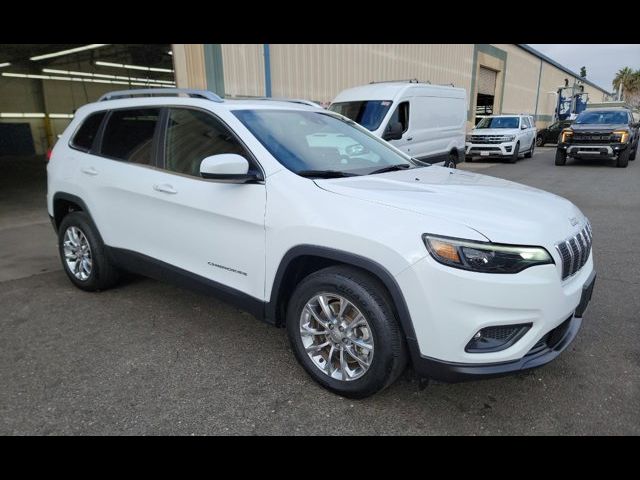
(165, 108, 248, 177)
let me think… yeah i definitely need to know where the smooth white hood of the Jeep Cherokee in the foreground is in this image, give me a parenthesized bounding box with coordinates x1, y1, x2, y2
(315, 166, 584, 246)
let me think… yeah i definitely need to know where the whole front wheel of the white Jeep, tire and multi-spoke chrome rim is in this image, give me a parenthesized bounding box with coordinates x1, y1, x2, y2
(287, 266, 407, 398)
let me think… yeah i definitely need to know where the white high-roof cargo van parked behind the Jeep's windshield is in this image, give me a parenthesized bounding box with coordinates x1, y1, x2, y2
(329, 80, 467, 168)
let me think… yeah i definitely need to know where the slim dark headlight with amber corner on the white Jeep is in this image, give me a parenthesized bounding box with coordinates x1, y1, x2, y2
(422, 233, 553, 273)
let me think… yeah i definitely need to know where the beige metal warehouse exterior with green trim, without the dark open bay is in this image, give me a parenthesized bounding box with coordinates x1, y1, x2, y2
(173, 44, 608, 127)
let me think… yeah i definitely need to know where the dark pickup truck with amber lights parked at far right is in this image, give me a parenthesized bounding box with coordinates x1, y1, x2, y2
(556, 108, 640, 168)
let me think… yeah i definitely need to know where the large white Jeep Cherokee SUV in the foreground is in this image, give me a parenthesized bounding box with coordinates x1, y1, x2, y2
(47, 89, 595, 397)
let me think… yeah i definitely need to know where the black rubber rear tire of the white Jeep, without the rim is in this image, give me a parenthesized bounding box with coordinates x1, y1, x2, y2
(58, 212, 119, 292)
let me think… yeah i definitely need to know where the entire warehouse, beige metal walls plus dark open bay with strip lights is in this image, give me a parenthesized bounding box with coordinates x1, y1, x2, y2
(0, 44, 608, 156)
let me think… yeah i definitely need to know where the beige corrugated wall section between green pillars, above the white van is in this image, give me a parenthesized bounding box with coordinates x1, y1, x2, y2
(222, 44, 473, 102)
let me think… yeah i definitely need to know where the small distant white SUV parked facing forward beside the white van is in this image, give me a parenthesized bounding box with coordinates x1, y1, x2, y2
(466, 115, 536, 163)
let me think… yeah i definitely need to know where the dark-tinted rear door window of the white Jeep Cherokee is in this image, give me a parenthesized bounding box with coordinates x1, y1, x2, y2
(100, 108, 160, 165)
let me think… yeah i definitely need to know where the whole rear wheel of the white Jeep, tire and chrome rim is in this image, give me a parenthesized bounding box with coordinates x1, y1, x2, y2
(58, 212, 118, 291)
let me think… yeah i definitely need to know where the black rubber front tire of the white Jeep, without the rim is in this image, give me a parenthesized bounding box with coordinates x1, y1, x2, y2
(287, 266, 407, 398)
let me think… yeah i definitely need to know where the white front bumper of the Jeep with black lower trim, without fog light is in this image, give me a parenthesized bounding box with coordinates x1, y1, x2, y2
(396, 249, 595, 381)
